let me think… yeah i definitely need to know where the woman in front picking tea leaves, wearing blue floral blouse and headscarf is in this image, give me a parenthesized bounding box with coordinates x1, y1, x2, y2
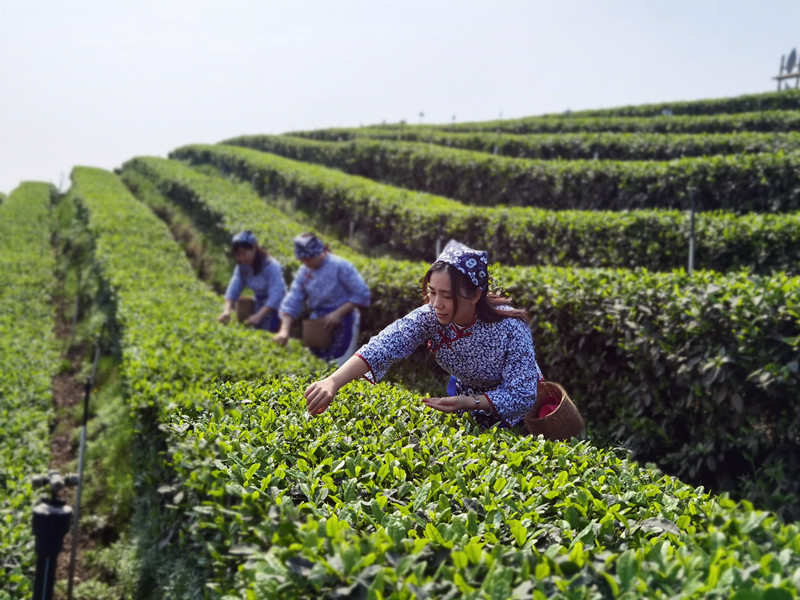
(305, 240, 542, 427)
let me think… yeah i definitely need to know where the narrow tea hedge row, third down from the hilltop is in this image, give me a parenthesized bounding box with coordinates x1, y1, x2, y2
(294, 126, 800, 161)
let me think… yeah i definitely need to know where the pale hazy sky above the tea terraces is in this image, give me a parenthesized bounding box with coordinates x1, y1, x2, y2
(0, 0, 800, 193)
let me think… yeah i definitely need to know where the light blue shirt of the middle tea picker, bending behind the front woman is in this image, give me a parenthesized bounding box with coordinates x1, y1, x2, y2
(280, 254, 370, 319)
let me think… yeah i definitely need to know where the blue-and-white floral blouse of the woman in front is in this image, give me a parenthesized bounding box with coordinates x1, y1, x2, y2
(356, 305, 542, 427)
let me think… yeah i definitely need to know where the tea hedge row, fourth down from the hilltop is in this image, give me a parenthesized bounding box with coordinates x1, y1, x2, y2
(225, 136, 800, 213)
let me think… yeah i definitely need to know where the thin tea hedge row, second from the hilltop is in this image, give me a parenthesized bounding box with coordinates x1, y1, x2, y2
(440, 110, 800, 133)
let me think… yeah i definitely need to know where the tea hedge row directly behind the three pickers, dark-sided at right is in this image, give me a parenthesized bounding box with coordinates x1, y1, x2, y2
(125, 151, 800, 510)
